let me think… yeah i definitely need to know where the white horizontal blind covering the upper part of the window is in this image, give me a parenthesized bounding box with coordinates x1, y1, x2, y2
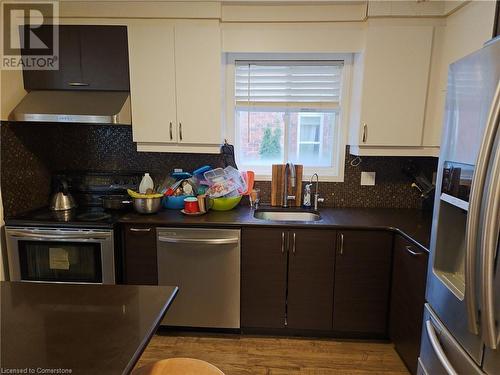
(235, 61, 343, 108)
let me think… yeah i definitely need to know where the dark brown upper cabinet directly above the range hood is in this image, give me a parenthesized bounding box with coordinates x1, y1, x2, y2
(23, 25, 130, 91)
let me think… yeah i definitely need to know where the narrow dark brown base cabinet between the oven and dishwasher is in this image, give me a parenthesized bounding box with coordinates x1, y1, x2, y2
(123, 225, 158, 285)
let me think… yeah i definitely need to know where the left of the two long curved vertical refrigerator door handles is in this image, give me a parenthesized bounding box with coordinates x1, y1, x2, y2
(465, 84, 500, 335)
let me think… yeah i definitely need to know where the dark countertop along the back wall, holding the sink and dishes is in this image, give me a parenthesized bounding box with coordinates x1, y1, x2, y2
(120, 206, 432, 249)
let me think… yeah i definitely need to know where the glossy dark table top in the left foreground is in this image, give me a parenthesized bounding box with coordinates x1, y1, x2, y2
(0, 282, 178, 374)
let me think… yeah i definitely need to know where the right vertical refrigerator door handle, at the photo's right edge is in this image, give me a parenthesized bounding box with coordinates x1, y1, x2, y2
(480, 103, 500, 349)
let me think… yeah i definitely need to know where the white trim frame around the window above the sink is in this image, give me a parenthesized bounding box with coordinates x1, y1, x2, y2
(223, 53, 353, 182)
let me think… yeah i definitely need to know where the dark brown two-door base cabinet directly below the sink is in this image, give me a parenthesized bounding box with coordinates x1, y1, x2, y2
(241, 228, 335, 330)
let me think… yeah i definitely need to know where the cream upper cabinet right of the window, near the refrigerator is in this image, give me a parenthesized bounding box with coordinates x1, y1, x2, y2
(350, 25, 433, 154)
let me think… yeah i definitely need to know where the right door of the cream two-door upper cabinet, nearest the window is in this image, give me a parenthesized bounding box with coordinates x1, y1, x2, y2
(175, 21, 222, 145)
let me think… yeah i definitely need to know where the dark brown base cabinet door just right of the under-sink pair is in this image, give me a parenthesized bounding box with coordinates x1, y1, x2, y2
(333, 230, 393, 336)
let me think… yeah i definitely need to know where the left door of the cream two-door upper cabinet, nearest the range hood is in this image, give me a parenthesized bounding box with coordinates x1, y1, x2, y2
(128, 21, 177, 143)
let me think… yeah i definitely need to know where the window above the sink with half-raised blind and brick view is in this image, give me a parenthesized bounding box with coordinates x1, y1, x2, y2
(230, 59, 345, 180)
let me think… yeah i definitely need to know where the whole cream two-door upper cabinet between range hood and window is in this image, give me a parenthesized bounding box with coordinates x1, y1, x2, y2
(128, 20, 222, 153)
